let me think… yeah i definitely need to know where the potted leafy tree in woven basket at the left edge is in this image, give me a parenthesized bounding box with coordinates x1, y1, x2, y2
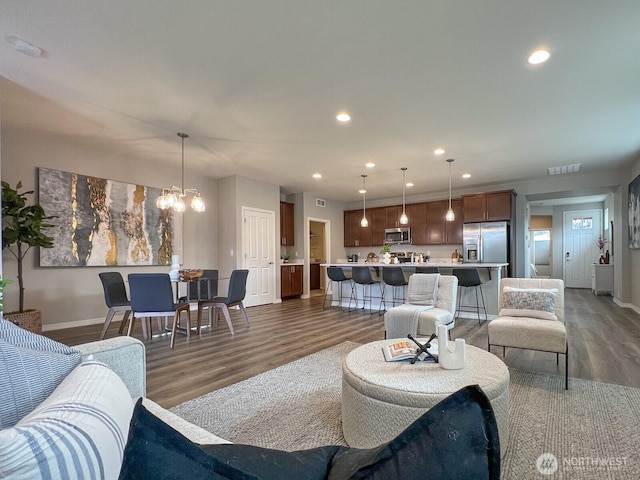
(2, 181, 53, 331)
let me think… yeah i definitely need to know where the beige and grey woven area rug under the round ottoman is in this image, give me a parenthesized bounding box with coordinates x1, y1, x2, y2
(171, 342, 640, 480)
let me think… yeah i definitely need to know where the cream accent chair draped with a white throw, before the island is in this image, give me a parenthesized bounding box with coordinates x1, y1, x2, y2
(384, 273, 458, 338)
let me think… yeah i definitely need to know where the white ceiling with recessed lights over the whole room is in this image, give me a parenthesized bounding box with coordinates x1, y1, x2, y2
(0, 0, 640, 201)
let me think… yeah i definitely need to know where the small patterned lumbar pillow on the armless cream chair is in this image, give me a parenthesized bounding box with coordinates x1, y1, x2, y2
(499, 287, 558, 320)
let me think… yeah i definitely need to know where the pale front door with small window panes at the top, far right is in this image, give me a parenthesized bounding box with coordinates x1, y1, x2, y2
(562, 210, 602, 288)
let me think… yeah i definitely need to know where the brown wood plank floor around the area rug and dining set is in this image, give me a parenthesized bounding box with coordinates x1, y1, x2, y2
(45, 289, 640, 408)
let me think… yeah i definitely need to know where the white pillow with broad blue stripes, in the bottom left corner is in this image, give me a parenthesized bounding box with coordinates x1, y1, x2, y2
(0, 362, 134, 480)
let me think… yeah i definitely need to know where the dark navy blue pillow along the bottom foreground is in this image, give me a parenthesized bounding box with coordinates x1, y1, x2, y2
(120, 386, 500, 480)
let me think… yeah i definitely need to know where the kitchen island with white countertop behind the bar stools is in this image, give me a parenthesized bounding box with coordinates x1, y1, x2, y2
(322, 261, 509, 320)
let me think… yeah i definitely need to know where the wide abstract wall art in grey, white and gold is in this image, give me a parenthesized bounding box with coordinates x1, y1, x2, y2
(38, 168, 173, 267)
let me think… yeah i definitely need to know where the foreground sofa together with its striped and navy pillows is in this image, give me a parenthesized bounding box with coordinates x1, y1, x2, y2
(0, 318, 500, 480)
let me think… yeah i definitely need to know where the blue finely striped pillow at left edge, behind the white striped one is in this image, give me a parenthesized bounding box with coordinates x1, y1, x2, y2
(0, 318, 82, 428)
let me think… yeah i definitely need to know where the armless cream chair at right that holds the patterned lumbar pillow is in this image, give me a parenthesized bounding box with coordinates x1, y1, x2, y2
(488, 278, 569, 389)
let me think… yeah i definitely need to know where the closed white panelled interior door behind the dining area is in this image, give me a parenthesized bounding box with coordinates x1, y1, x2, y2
(242, 207, 276, 307)
